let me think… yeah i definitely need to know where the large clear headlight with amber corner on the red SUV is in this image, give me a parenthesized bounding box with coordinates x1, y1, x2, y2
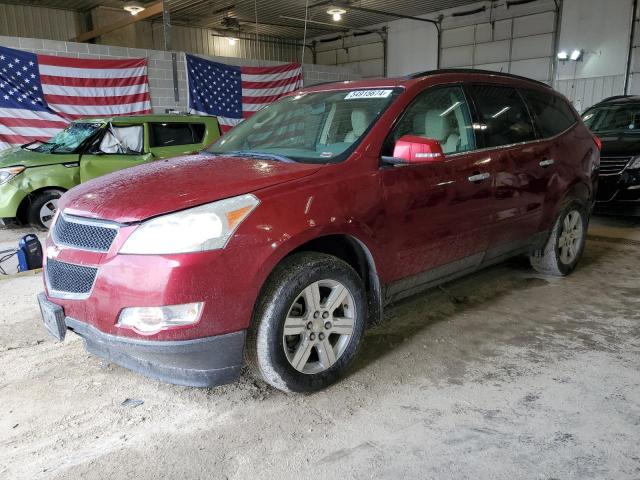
(120, 194, 260, 255)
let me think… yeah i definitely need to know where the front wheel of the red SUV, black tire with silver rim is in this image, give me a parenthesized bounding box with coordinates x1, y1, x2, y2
(245, 252, 366, 392)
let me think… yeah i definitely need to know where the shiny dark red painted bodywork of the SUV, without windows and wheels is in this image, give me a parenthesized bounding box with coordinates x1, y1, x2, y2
(46, 73, 598, 340)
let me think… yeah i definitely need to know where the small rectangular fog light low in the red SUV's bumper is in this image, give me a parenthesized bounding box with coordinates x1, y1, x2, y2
(117, 302, 203, 335)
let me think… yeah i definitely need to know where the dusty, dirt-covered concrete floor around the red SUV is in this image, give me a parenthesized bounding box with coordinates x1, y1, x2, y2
(0, 218, 640, 480)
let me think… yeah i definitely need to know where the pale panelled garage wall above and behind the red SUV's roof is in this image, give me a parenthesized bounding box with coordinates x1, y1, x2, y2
(318, 0, 640, 110)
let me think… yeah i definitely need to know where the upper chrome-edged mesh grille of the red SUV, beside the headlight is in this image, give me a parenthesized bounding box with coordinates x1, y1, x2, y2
(51, 214, 118, 252)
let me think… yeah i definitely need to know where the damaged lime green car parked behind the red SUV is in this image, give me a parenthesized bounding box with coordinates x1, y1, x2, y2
(0, 115, 220, 228)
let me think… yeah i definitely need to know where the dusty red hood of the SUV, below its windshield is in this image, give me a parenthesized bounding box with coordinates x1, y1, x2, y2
(59, 154, 322, 223)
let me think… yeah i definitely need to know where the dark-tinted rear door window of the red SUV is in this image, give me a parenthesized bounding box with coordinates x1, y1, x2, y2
(469, 85, 536, 147)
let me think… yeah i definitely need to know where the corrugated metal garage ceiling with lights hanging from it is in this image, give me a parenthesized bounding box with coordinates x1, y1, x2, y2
(1, 0, 477, 39)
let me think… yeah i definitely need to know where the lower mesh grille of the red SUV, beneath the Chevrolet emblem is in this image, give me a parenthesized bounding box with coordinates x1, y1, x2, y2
(45, 258, 98, 298)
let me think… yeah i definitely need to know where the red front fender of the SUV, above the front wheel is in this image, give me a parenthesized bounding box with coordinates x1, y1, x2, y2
(229, 167, 385, 320)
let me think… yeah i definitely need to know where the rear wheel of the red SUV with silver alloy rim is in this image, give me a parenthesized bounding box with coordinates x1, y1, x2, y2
(529, 202, 589, 276)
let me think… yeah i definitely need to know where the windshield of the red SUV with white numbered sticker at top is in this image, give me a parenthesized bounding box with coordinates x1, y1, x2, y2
(208, 88, 401, 163)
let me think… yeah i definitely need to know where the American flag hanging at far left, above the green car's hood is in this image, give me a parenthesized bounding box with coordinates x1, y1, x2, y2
(0, 47, 151, 148)
